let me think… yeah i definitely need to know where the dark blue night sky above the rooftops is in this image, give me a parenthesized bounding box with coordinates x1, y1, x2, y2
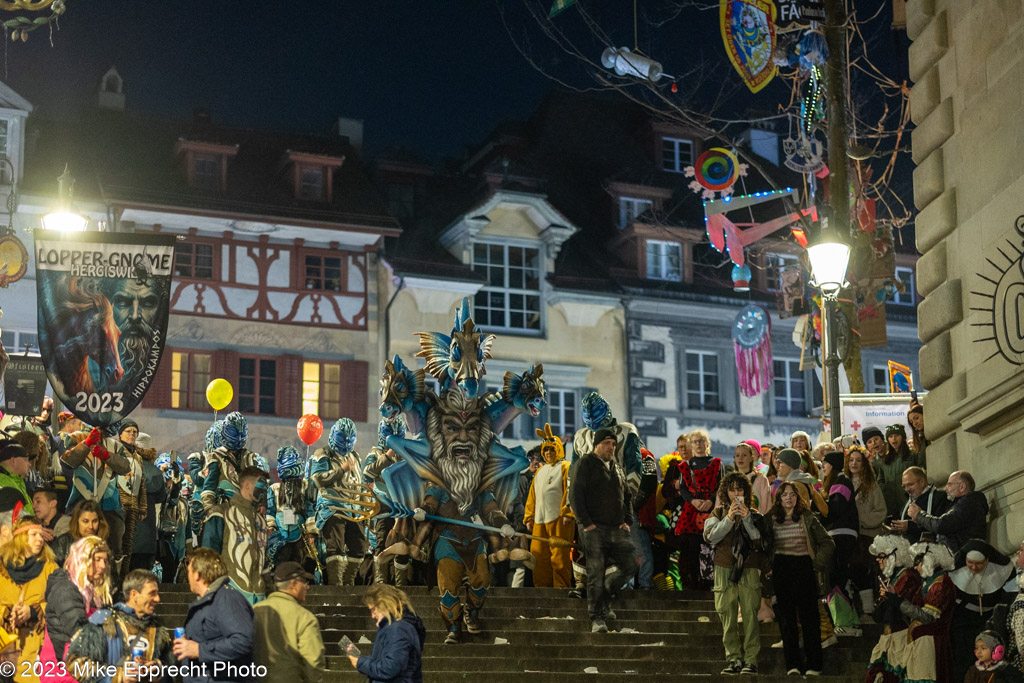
(0, 0, 909, 167)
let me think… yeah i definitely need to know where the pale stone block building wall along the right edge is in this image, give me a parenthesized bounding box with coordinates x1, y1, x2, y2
(907, 0, 1024, 551)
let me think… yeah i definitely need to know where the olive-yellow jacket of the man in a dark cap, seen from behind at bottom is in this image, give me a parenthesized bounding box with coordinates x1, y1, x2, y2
(253, 592, 327, 683)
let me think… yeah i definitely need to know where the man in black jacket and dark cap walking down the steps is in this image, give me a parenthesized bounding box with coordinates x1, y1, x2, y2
(569, 429, 637, 633)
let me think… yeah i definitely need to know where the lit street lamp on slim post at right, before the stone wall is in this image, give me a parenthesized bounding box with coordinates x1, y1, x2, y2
(807, 222, 850, 439)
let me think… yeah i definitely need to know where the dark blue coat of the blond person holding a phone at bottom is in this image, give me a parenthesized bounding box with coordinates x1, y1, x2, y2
(355, 609, 427, 683)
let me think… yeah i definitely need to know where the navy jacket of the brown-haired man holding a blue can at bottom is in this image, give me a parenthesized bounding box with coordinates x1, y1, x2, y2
(181, 577, 253, 683)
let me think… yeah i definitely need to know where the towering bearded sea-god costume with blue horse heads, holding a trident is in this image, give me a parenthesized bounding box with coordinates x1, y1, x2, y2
(374, 299, 544, 643)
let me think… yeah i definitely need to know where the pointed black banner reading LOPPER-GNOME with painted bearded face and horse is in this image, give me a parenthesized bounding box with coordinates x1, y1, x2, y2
(34, 230, 175, 426)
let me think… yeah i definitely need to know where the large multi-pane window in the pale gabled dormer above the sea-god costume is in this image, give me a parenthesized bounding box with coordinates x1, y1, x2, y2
(473, 243, 541, 331)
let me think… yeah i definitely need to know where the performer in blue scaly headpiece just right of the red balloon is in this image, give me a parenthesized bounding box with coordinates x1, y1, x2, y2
(310, 418, 367, 586)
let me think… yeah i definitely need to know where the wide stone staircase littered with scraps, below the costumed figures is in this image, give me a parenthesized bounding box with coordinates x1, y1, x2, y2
(157, 584, 880, 683)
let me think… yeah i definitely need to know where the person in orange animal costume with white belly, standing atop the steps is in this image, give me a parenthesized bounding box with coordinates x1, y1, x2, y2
(522, 424, 575, 588)
